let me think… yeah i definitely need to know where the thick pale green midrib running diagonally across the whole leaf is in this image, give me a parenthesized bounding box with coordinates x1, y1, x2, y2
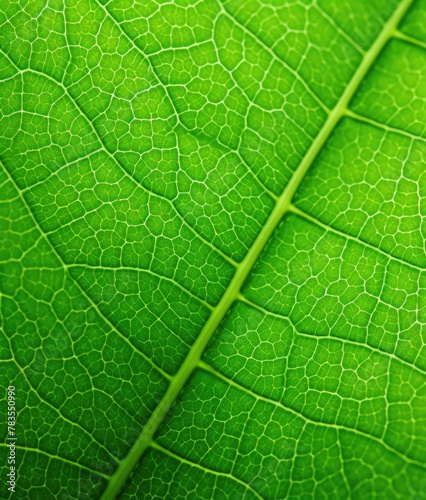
(101, 0, 413, 500)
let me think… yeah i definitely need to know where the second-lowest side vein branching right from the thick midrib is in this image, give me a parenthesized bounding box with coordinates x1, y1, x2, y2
(199, 361, 426, 469)
